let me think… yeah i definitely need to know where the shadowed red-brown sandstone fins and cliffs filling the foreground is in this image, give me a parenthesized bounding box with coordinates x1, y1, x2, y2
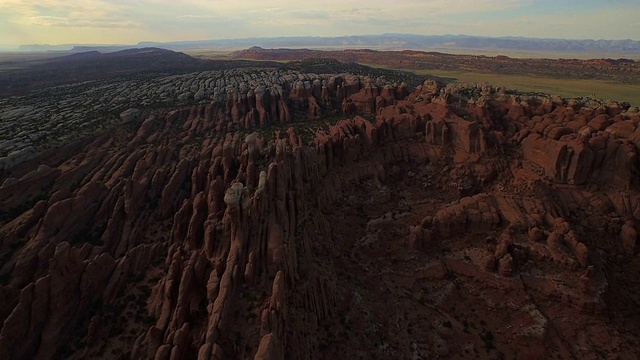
(0, 74, 640, 359)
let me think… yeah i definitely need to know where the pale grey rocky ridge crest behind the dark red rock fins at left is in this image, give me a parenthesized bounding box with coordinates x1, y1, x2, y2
(0, 69, 410, 170)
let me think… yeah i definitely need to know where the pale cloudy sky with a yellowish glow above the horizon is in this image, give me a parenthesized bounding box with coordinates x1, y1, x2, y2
(0, 0, 640, 47)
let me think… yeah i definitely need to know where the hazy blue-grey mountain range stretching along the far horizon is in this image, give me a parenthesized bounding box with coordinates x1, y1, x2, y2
(13, 34, 640, 56)
